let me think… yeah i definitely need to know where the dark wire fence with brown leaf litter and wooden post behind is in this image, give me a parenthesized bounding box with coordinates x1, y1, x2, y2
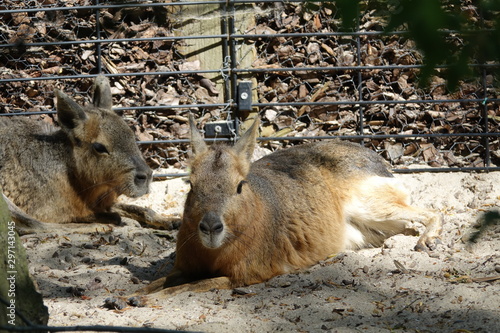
(0, 0, 500, 174)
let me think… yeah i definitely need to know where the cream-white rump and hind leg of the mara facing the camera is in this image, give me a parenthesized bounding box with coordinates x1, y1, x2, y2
(345, 177, 443, 251)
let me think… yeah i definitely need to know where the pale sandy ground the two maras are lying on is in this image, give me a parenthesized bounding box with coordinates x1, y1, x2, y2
(22, 169, 500, 332)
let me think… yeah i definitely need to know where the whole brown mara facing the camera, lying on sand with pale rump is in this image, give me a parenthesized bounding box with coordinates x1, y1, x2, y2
(123, 118, 442, 297)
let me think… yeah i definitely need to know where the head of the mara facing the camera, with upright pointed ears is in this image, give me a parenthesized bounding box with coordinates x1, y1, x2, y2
(183, 117, 259, 249)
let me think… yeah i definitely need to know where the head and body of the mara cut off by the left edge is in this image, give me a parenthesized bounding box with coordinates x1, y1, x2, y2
(0, 76, 152, 223)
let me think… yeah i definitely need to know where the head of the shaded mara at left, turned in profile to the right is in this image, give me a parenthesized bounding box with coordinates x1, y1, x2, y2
(55, 76, 152, 197)
